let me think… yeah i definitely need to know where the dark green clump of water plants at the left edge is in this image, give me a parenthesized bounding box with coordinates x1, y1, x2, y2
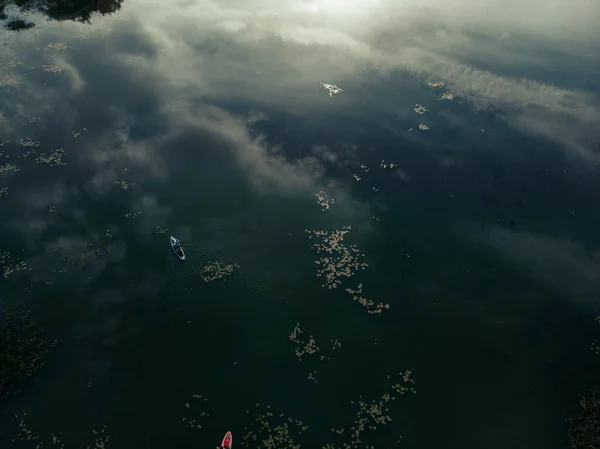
(0, 310, 56, 399)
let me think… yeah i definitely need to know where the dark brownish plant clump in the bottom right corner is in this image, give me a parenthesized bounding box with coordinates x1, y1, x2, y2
(568, 391, 600, 449)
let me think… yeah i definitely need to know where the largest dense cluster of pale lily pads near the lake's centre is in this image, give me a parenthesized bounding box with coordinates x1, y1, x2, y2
(304, 226, 368, 289)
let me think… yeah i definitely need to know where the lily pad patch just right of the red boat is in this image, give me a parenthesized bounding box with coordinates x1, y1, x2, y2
(241, 404, 308, 449)
